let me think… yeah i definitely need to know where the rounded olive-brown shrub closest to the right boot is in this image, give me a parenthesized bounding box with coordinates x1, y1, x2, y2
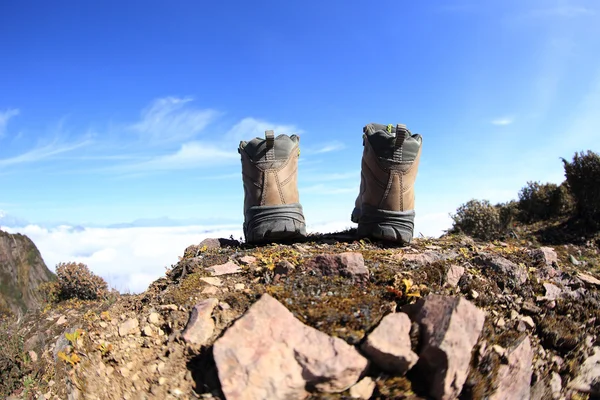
(450, 200, 502, 240)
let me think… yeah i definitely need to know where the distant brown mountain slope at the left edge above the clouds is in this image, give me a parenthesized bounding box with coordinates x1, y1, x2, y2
(0, 230, 54, 314)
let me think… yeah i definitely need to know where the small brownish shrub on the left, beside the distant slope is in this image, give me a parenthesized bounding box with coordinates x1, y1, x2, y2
(56, 262, 108, 300)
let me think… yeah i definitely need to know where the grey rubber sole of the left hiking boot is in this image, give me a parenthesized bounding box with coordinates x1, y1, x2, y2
(244, 203, 306, 244)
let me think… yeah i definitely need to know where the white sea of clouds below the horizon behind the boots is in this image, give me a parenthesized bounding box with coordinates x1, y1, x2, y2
(2, 214, 450, 293)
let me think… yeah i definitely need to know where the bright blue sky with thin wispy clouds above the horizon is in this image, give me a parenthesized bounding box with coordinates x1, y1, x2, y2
(0, 0, 600, 288)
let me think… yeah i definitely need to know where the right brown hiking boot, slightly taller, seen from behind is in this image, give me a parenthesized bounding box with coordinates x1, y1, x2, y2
(352, 124, 422, 244)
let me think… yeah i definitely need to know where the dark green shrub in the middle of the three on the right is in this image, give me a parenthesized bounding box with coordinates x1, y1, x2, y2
(518, 182, 572, 223)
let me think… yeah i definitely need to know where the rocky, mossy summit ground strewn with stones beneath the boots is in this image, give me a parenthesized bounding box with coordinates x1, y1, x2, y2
(1, 233, 600, 400)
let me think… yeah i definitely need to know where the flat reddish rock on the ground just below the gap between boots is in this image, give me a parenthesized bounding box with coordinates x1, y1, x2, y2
(304, 252, 369, 278)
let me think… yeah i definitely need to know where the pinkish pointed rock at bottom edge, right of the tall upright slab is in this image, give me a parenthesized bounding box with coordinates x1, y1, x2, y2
(489, 336, 533, 400)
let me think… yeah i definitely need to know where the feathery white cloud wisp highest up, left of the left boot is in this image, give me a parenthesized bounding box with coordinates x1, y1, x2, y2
(129, 97, 219, 144)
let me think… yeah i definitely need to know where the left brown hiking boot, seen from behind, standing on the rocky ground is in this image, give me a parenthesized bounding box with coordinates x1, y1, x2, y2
(238, 131, 306, 243)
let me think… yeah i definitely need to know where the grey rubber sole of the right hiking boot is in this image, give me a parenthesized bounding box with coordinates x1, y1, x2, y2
(351, 205, 415, 244)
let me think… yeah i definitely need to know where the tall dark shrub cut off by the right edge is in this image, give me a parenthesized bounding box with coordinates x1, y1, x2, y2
(562, 150, 600, 228)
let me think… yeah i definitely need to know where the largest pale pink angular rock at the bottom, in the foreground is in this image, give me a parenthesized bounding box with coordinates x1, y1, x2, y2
(213, 294, 367, 400)
